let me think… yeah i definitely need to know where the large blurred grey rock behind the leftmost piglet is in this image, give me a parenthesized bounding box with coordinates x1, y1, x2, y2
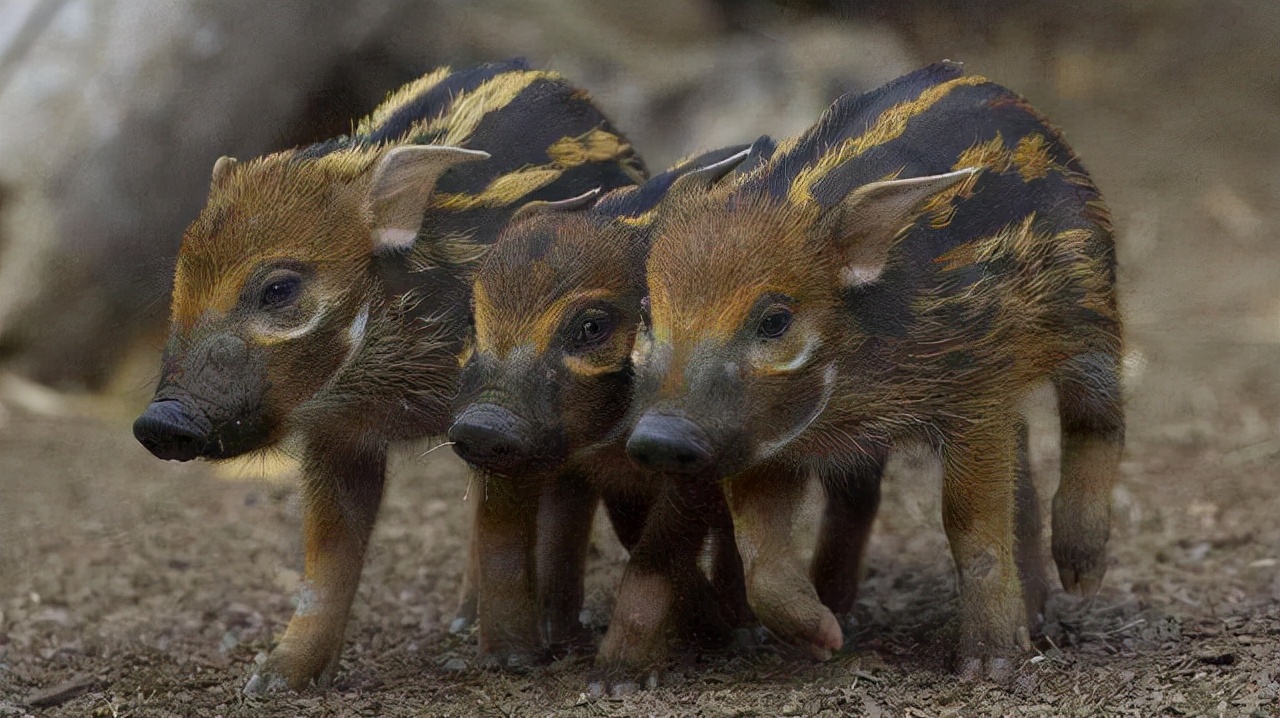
(0, 0, 437, 387)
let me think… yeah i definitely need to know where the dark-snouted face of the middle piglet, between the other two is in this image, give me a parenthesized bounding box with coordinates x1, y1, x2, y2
(449, 212, 644, 472)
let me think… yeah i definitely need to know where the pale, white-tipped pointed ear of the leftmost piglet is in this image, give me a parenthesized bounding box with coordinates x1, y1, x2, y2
(369, 145, 489, 250)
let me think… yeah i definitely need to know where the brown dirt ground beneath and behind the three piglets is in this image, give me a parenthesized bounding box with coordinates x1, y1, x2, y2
(0, 4, 1280, 717)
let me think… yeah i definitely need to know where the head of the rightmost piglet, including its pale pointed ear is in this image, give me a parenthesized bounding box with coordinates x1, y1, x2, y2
(627, 159, 973, 476)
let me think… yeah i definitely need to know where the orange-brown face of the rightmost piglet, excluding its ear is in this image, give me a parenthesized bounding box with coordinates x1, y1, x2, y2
(627, 192, 840, 476)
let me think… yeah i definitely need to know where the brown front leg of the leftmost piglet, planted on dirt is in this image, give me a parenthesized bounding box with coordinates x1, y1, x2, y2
(244, 440, 387, 695)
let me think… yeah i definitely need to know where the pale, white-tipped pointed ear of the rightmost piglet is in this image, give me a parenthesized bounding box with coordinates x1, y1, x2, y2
(823, 168, 980, 287)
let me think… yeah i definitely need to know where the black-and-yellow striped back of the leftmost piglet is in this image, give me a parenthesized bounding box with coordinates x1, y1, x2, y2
(293, 59, 645, 223)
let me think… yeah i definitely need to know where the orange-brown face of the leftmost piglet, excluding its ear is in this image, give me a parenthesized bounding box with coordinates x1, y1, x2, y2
(134, 157, 371, 461)
